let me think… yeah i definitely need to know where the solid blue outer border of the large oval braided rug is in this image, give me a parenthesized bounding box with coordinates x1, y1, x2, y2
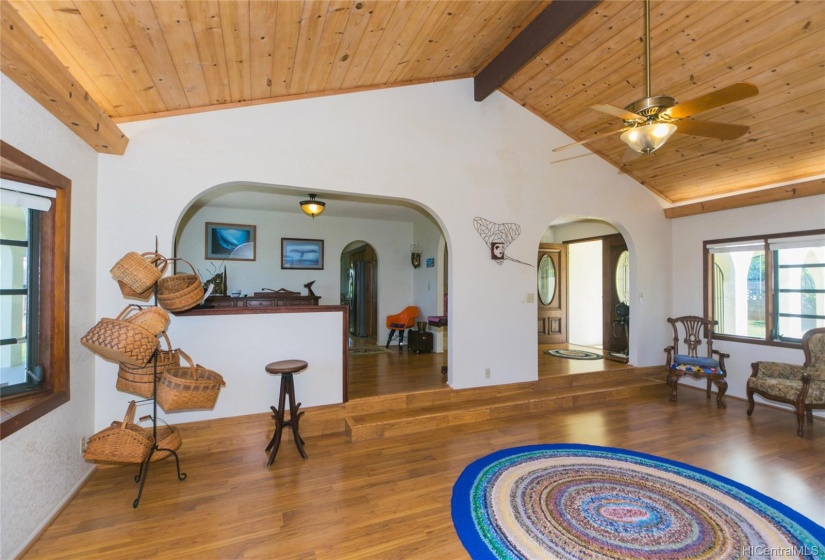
(450, 443, 825, 560)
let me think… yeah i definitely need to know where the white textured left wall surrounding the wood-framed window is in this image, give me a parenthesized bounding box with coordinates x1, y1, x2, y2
(0, 75, 97, 558)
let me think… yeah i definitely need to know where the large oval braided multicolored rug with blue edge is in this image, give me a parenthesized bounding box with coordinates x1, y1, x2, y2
(452, 444, 825, 560)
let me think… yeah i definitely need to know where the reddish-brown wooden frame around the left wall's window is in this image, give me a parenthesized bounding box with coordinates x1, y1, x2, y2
(0, 140, 71, 439)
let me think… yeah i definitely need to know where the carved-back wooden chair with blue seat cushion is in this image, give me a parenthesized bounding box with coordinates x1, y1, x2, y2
(665, 315, 730, 408)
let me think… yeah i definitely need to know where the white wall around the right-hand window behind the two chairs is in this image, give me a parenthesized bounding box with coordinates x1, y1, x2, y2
(662, 195, 825, 422)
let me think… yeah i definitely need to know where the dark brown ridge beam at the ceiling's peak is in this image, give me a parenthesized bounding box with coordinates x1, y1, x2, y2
(473, 0, 600, 101)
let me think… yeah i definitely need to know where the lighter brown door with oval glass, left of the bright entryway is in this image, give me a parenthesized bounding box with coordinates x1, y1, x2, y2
(536, 243, 567, 344)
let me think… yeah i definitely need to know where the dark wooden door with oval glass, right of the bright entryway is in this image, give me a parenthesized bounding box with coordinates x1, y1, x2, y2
(602, 234, 630, 359)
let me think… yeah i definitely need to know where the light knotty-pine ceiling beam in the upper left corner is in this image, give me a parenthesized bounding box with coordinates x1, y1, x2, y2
(0, 1, 129, 155)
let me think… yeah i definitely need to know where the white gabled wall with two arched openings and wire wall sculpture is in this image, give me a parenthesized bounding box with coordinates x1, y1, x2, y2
(97, 80, 670, 398)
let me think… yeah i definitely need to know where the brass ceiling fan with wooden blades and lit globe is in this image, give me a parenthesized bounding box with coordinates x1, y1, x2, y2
(553, 0, 759, 155)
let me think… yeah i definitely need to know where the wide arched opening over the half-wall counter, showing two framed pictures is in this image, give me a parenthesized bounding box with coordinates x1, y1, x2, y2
(170, 182, 448, 399)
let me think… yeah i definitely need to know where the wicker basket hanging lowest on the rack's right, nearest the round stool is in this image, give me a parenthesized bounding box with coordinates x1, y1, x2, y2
(155, 350, 226, 412)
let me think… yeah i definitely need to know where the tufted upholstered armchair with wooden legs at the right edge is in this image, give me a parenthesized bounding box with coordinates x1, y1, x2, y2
(747, 328, 825, 437)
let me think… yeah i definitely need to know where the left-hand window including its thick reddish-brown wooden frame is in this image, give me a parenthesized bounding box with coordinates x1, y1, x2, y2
(0, 140, 71, 438)
